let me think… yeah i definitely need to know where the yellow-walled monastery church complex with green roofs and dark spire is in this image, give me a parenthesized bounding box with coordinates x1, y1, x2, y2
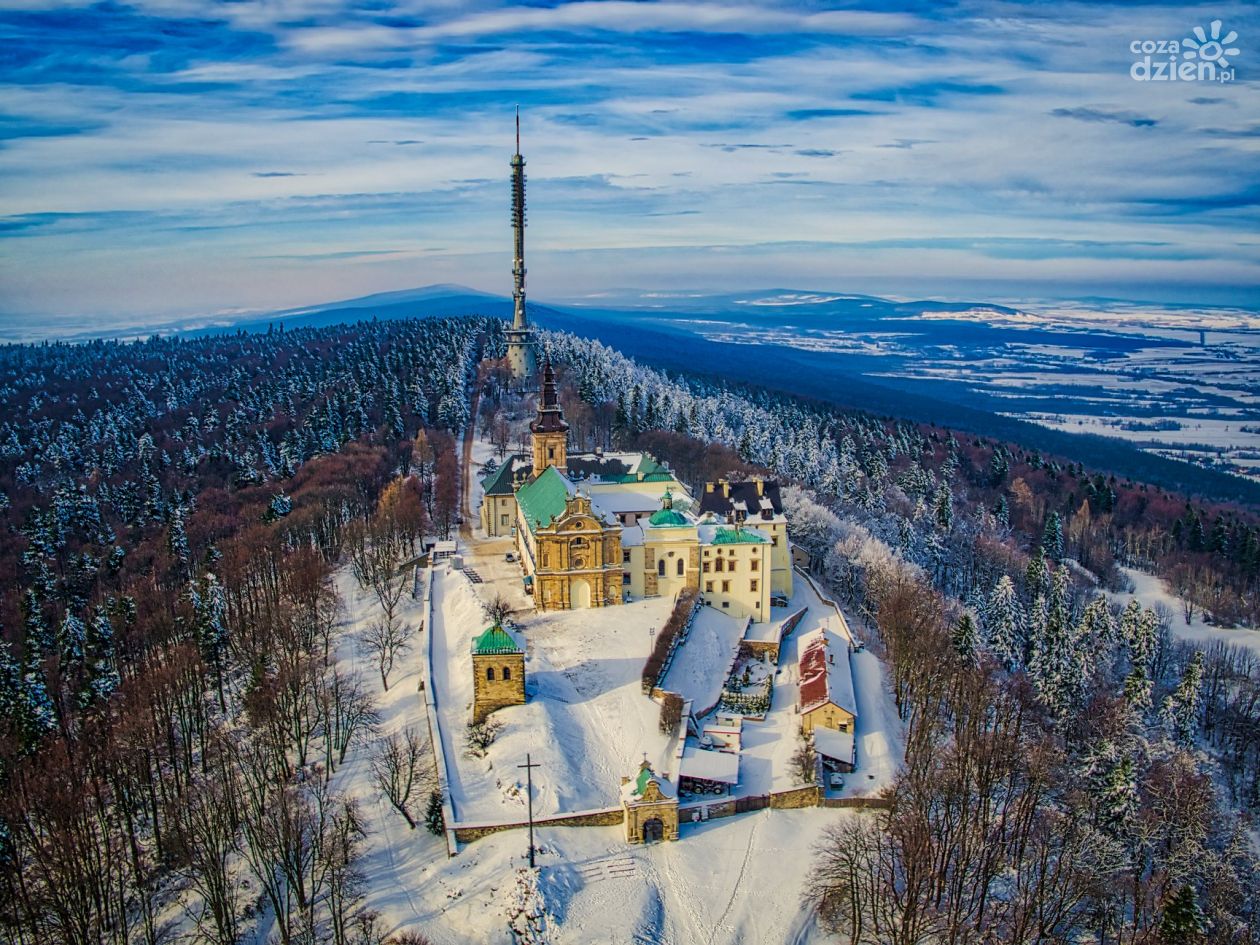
(481, 362, 791, 622)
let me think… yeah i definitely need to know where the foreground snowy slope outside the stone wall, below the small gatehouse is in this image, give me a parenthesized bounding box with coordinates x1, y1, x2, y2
(394, 808, 869, 945)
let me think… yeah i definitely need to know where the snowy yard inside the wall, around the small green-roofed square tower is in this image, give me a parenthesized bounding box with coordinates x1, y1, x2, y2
(432, 568, 670, 824)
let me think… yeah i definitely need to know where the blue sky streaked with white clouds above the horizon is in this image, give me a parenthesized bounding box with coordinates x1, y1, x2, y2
(0, 0, 1260, 335)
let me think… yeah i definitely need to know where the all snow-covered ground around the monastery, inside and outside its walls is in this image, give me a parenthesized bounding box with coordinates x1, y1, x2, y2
(315, 544, 901, 945)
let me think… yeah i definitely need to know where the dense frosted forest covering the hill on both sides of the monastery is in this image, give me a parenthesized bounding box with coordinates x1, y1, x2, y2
(0, 319, 1260, 945)
